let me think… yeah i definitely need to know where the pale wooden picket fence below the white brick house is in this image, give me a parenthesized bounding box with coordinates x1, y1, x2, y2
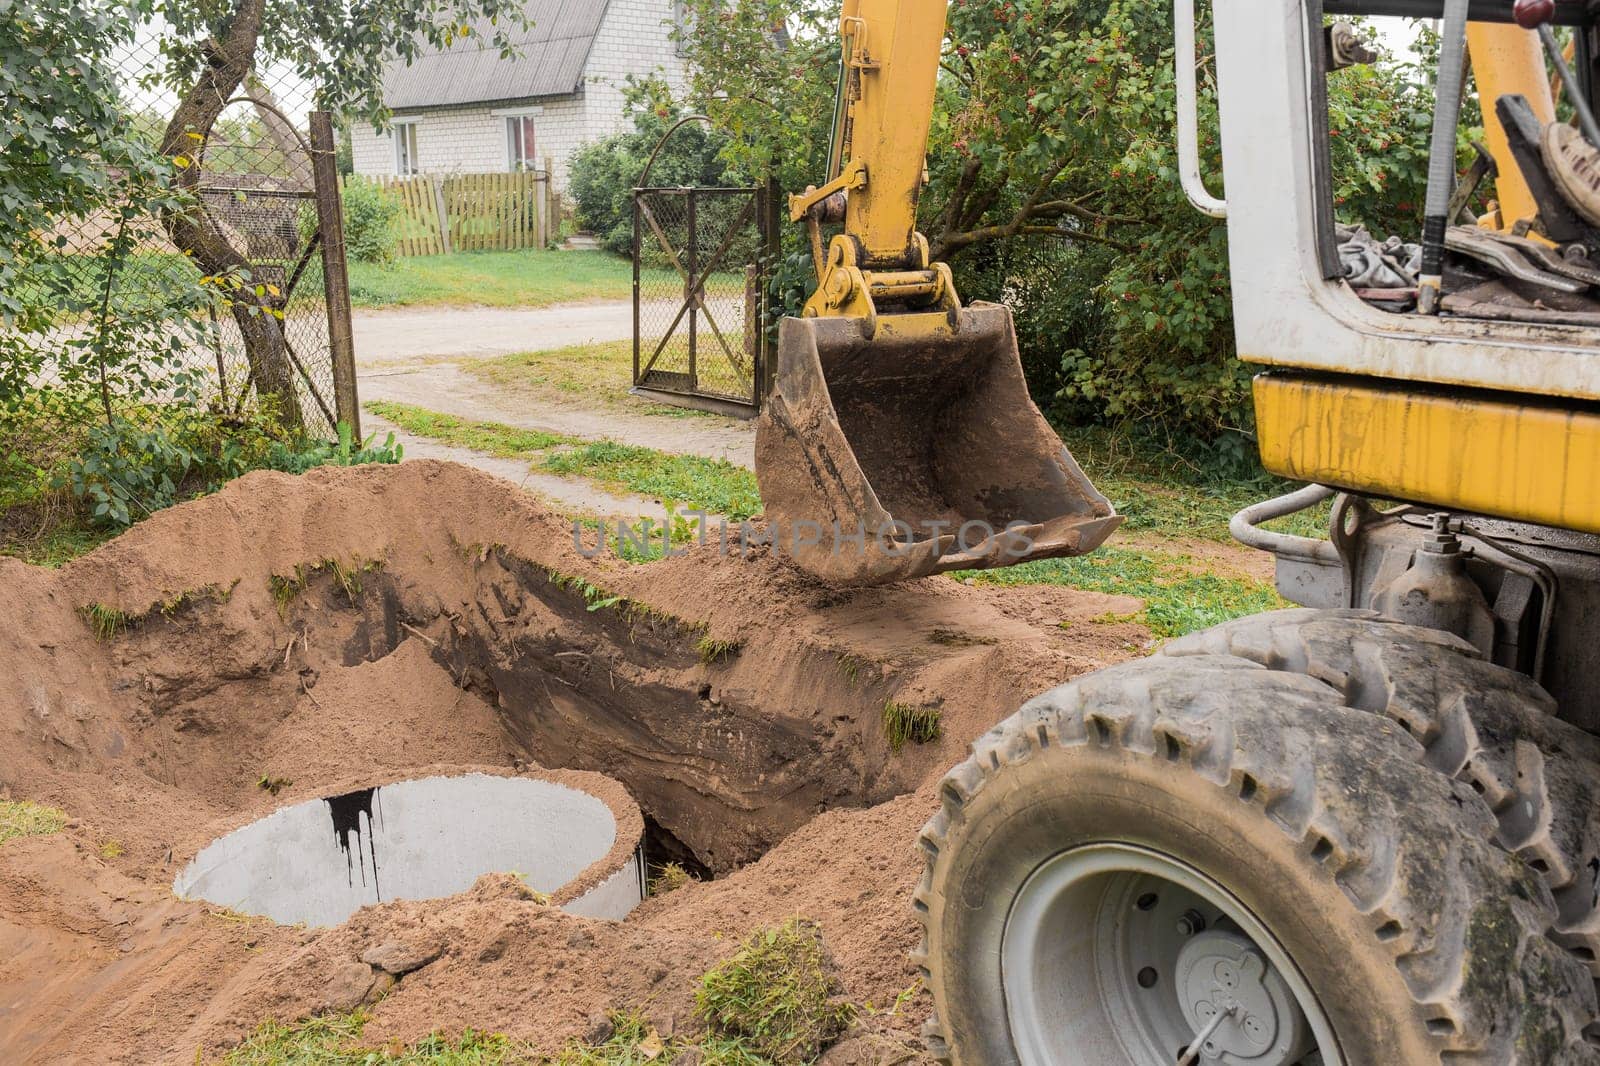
(344, 160, 560, 256)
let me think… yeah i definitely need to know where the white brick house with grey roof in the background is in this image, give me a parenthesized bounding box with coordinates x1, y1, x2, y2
(350, 0, 685, 187)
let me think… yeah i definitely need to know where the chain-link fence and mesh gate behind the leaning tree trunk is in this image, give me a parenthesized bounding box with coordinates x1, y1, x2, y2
(8, 27, 349, 447)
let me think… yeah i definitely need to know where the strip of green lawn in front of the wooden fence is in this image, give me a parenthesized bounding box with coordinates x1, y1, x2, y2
(350, 250, 652, 307)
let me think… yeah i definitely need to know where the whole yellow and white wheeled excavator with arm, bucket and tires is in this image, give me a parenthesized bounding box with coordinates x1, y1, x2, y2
(757, 0, 1600, 1066)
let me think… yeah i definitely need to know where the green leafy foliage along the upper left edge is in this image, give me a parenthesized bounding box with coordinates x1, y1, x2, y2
(0, 0, 194, 419)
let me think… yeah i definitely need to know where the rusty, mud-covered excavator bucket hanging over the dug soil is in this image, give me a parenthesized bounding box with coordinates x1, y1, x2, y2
(755, 304, 1122, 586)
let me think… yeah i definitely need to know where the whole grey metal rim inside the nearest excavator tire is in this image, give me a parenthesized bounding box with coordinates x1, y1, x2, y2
(1000, 842, 1346, 1066)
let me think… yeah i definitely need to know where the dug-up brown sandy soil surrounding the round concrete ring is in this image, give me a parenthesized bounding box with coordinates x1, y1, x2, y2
(0, 463, 1146, 1063)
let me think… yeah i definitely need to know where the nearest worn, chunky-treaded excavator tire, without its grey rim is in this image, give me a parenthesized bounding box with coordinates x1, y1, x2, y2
(915, 633, 1600, 1066)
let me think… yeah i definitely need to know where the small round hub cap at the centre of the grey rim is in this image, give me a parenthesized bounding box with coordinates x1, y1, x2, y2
(1174, 928, 1310, 1066)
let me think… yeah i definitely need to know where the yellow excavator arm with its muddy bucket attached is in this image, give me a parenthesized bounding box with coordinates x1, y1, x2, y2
(755, 0, 1122, 584)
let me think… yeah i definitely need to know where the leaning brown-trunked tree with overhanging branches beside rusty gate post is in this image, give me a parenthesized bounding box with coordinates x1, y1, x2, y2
(133, 0, 526, 423)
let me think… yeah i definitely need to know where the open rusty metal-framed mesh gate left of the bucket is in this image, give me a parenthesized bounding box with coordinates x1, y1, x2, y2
(634, 189, 778, 418)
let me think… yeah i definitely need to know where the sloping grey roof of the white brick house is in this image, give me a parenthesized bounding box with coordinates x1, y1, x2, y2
(384, 0, 610, 110)
